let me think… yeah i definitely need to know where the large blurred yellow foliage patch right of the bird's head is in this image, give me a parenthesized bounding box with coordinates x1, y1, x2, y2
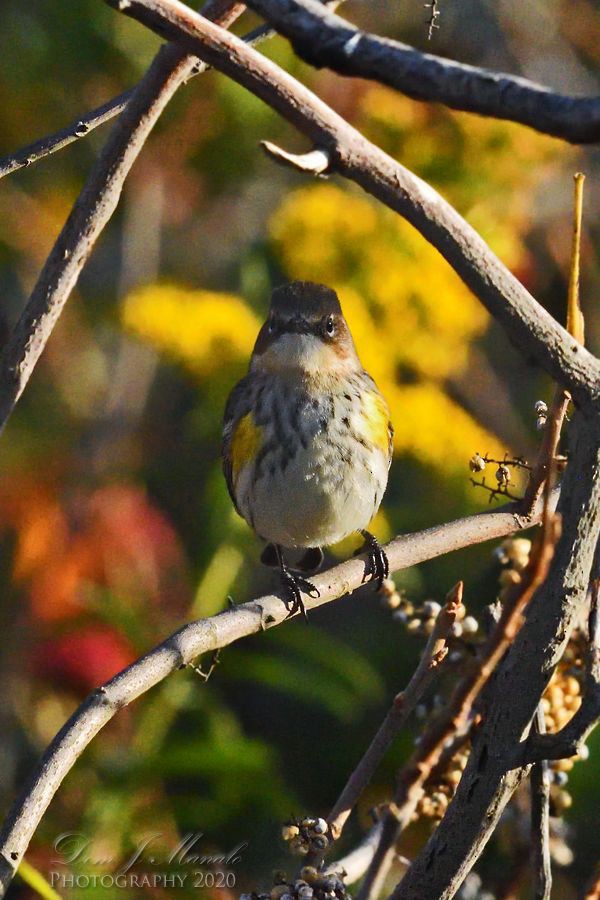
(270, 184, 506, 472)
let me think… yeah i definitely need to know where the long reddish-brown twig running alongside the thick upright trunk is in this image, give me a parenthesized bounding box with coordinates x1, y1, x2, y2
(359, 502, 560, 900)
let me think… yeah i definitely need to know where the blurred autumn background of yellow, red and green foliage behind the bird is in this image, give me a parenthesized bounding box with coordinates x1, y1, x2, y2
(0, 0, 600, 900)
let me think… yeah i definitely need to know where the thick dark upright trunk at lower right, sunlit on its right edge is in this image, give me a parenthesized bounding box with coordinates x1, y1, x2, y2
(393, 412, 600, 900)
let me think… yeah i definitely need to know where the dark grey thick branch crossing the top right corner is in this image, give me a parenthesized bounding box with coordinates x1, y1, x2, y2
(241, 0, 600, 144)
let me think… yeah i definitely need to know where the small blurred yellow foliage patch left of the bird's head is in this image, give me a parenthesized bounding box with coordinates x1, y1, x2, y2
(122, 284, 260, 378)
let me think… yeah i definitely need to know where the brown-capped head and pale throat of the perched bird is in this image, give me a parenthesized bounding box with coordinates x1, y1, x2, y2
(251, 281, 360, 376)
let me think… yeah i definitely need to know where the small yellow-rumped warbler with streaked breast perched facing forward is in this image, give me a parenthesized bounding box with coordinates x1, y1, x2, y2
(222, 281, 393, 615)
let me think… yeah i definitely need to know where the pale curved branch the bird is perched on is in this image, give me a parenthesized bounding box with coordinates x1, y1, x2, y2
(0, 504, 541, 895)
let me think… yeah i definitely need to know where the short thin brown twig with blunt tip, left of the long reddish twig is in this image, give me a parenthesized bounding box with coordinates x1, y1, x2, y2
(327, 581, 463, 840)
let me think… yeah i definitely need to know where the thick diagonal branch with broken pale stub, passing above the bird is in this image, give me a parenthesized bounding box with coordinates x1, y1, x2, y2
(105, 0, 600, 402)
